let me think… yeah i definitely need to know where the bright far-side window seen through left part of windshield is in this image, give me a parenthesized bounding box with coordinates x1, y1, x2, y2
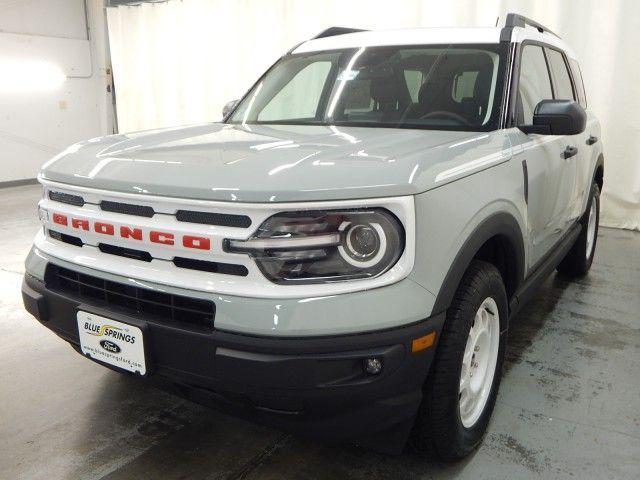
(258, 61, 331, 121)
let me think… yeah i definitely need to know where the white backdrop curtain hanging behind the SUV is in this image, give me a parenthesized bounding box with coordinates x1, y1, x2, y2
(107, 0, 640, 229)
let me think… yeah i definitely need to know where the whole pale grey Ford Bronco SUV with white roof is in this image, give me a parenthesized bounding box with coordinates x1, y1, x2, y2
(23, 14, 604, 459)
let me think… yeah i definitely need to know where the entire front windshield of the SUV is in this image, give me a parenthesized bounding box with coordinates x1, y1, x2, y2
(228, 44, 505, 131)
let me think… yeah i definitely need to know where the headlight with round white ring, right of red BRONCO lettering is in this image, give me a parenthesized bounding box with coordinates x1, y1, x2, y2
(225, 208, 405, 284)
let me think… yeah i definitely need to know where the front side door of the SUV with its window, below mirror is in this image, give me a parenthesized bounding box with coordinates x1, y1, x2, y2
(511, 43, 575, 269)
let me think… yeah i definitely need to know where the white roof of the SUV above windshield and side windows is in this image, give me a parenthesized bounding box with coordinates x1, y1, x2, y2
(293, 27, 575, 58)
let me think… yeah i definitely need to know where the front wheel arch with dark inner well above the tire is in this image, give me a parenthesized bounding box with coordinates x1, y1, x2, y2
(433, 212, 525, 313)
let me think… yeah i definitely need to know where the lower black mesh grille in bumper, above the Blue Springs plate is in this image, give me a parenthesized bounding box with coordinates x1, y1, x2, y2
(45, 264, 215, 331)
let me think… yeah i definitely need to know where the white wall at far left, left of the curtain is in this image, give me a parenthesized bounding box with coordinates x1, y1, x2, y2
(0, 0, 113, 183)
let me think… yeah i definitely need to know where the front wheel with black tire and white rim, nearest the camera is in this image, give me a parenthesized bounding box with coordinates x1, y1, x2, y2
(411, 260, 508, 461)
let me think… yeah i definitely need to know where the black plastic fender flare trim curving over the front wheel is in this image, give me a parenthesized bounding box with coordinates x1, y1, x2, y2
(433, 212, 525, 313)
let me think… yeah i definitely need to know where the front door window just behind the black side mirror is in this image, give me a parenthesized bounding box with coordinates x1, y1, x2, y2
(517, 45, 553, 125)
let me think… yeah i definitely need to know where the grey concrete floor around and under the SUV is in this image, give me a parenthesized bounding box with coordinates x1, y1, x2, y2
(0, 182, 640, 480)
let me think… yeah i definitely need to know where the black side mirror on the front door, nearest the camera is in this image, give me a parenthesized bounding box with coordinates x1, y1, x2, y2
(518, 100, 587, 135)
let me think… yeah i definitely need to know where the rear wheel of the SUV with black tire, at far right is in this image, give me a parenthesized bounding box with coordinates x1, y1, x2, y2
(558, 183, 600, 277)
